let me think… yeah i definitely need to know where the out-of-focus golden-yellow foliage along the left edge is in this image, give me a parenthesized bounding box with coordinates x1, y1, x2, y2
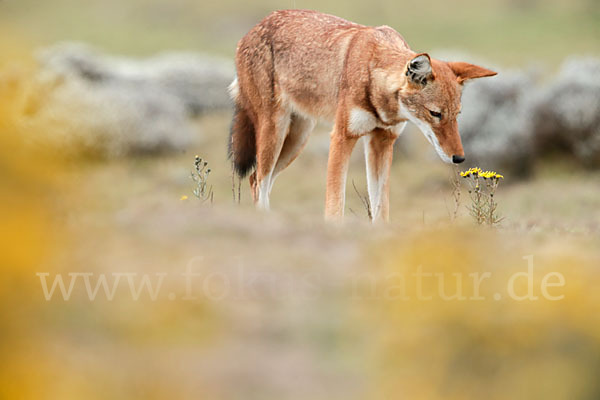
(0, 35, 66, 398)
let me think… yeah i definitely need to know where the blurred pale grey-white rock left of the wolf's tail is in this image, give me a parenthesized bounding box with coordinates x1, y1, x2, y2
(26, 43, 233, 158)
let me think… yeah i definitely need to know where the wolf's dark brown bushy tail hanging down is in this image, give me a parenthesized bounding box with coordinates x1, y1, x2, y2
(229, 104, 256, 178)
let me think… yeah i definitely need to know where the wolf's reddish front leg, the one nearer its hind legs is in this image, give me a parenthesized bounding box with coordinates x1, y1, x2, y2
(325, 128, 358, 220)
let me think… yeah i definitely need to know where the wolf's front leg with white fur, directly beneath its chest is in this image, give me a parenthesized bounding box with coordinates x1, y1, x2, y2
(364, 129, 398, 222)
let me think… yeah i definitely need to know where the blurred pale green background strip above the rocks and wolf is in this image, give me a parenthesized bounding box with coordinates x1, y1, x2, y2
(0, 0, 600, 66)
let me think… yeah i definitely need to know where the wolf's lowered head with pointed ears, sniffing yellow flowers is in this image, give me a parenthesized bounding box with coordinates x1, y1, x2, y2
(398, 53, 496, 164)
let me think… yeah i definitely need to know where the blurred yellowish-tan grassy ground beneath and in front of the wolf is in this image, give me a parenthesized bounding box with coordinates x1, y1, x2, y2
(9, 113, 600, 399)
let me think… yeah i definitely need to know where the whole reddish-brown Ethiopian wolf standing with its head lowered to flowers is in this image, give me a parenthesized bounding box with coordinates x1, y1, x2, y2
(229, 10, 496, 220)
